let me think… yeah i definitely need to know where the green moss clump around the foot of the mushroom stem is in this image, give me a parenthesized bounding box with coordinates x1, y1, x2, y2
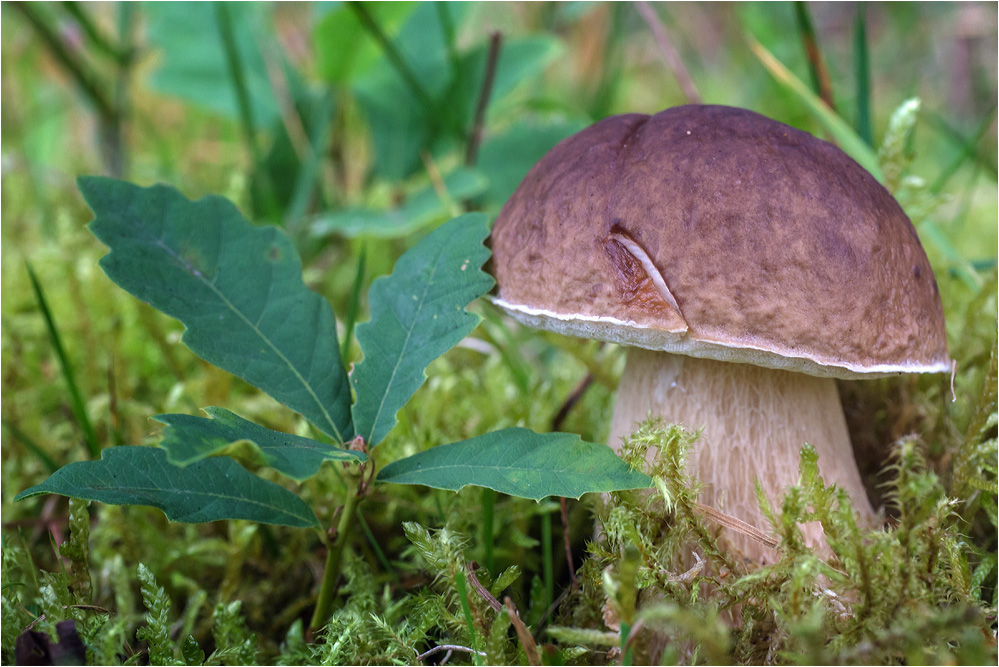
(558, 413, 996, 664)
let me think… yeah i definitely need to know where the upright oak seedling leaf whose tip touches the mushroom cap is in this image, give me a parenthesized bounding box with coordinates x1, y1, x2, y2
(351, 213, 493, 447)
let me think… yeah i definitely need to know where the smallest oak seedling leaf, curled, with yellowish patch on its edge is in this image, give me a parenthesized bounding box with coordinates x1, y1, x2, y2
(153, 407, 368, 481)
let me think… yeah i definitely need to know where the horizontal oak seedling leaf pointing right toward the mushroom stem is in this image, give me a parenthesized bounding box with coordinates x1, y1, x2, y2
(378, 428, 652, 500)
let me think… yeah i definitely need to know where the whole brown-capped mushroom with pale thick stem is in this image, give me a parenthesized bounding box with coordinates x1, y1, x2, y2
(491, 105, 951, 563)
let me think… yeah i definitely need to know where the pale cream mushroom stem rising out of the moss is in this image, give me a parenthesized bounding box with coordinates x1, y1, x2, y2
(610, 347, 874, 564)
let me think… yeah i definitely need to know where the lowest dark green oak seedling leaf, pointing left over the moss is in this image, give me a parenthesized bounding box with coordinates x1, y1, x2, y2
(14, 447, 318, 527)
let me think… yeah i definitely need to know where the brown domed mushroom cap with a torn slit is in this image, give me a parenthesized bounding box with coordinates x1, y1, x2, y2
(492, 105, 950, 378)
